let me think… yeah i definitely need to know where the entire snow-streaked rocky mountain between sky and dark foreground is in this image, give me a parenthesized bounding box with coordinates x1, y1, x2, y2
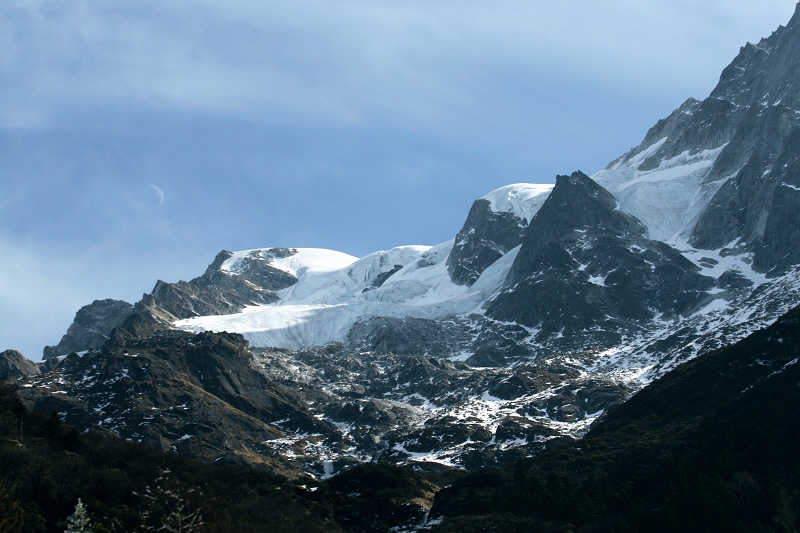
(10, 4, 800, 475)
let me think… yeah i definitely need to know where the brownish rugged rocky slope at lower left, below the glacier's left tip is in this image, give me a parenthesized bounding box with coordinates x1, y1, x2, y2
(20, 320, 336, 475)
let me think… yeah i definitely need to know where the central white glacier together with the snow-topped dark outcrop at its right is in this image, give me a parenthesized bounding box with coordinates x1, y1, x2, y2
(168, 184, 552, 349)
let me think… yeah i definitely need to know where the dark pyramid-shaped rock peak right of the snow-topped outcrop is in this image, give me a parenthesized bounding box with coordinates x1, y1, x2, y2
(488, 172, 713, 341)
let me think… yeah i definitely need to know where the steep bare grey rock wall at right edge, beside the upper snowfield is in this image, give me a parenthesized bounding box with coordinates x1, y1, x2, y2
(691, 11, 800, 274)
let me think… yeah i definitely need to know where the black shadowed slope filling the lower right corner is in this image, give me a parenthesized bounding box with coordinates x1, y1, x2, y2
(424, 308, 800, 532)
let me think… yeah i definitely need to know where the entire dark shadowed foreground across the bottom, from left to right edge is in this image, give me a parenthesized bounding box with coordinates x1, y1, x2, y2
(0, 308, 800, 532)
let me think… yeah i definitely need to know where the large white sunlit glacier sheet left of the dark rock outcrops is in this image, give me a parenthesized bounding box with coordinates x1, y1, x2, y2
(175, 241, 518, 349)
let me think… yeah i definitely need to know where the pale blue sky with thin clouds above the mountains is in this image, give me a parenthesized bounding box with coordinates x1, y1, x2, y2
(0, 0, 795, 360)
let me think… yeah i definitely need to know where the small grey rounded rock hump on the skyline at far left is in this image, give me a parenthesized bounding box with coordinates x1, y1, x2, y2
(44, 299, 133, 359)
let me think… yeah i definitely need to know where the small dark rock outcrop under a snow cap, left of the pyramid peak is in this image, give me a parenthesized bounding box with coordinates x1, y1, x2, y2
(447, 199, 528, 285)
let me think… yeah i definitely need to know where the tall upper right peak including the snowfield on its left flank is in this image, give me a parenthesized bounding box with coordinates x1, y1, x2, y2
(596, 11, 800, 276)
